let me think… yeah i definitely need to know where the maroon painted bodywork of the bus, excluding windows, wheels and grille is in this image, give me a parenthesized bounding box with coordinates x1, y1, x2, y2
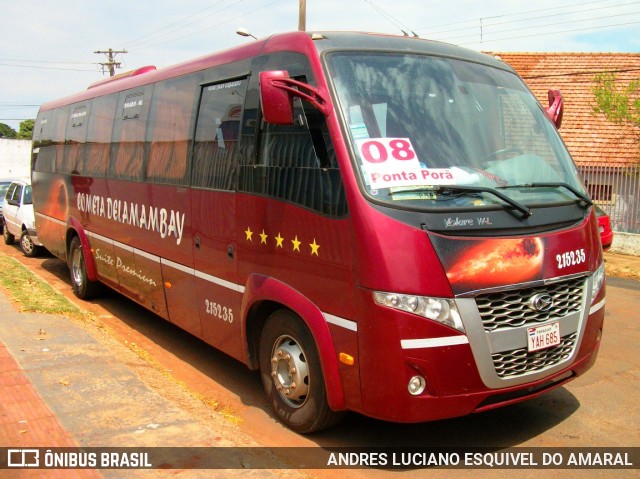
(34, 32, 604, 422)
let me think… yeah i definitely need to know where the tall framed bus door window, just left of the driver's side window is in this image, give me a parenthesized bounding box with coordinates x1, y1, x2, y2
(191, 78, 247, 190)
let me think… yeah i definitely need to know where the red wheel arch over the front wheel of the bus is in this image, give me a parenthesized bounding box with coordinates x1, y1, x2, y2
(242, 275, 346, 411)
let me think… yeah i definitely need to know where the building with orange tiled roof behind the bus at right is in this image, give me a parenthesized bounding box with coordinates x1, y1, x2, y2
(493, 53, 640, 247)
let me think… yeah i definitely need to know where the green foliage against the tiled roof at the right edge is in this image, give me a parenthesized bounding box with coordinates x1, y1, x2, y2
(591, 73, 640, 128)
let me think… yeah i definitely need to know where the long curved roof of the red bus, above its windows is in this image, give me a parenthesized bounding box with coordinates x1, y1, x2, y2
(40, 32, 513, 111)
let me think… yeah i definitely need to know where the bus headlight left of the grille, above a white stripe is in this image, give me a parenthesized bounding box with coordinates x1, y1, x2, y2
(373, 291, 464, 333)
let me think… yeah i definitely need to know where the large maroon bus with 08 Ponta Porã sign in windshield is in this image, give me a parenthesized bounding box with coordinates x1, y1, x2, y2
(33, 32, 605, 433)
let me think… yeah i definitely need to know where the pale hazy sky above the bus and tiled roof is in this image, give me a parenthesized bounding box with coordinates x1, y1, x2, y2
(0, 0, 640, 131)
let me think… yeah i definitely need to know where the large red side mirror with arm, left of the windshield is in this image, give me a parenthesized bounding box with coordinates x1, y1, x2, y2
(260, 70, 331, 125)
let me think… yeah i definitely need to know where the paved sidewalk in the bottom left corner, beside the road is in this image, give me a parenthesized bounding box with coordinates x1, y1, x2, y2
(0, 292, 288, 478)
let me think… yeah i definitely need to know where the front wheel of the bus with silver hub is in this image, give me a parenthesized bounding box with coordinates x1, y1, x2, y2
(258, 310, 344, 434)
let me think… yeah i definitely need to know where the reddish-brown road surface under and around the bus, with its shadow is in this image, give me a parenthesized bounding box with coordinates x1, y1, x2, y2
(0, 245, 640, 478)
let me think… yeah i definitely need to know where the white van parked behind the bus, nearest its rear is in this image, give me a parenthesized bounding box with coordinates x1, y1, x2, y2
(2, 180, 43, 257)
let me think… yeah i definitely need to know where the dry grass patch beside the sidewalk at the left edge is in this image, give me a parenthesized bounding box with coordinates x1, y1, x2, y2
(0, 254, 87, 317)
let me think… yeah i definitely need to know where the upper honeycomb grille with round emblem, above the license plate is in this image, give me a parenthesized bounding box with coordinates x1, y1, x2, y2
(476, 277, 585, 331)
